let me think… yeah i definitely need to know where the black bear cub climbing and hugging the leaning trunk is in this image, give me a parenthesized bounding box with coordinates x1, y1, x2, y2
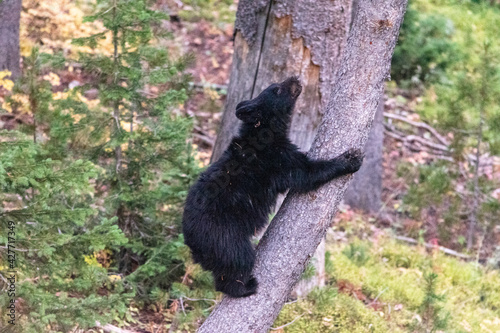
(182, 77, 363, 297)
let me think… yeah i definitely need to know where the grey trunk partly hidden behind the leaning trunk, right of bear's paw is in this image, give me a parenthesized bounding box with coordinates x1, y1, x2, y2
(344, 94, 384, 213)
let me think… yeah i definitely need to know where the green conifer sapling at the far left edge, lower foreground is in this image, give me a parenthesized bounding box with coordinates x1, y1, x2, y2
(0, 48, 132, 333)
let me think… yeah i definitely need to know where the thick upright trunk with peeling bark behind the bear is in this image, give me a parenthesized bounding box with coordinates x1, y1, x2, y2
(212, 0, 352, 296)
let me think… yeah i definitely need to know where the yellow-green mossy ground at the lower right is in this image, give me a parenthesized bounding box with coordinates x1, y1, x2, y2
(274, 232, 500, 333)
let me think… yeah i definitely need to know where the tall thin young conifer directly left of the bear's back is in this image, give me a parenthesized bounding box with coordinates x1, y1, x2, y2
(74, 0, 198, 300)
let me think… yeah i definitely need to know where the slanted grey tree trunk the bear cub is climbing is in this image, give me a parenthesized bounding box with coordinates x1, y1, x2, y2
(199, 0, 407, 333)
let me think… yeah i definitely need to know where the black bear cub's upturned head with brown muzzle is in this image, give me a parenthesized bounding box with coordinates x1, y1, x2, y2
(236, 76, 302, 127)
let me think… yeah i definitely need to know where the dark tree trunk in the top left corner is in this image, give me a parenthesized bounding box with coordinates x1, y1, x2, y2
(0, 0, 21, 79)
